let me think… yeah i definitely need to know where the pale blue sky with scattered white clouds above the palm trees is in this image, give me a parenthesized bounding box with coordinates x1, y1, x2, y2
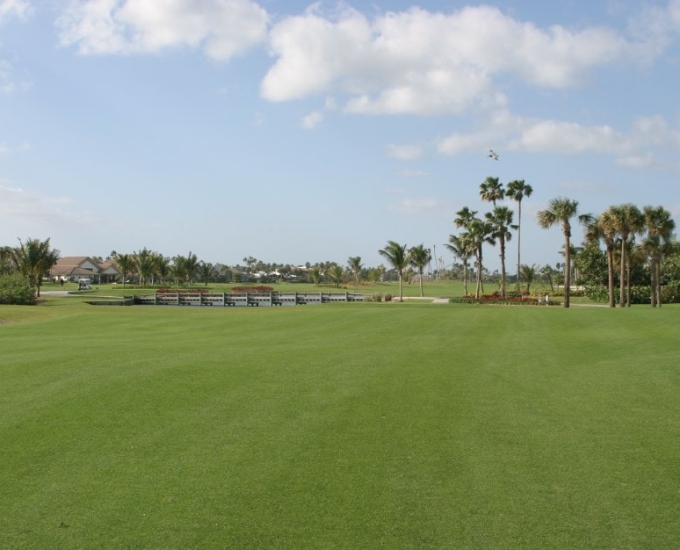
(0, 0, 680, 272)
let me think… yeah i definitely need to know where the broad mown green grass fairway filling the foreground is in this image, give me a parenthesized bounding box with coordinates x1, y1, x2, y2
(0, 298, 680, 549)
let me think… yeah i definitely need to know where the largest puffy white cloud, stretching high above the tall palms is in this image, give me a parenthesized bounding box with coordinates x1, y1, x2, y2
(261, 0, 652, 115)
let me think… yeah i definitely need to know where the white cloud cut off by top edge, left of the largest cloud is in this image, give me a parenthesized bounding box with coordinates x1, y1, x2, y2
(56, 0, 269, 61)
